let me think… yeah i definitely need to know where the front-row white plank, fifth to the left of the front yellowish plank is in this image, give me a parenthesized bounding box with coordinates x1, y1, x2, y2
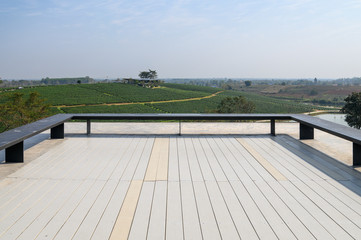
(18, 180, 82, 240)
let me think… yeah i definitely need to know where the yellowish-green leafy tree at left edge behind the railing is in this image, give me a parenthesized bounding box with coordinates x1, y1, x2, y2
(0, 92, 49, 131)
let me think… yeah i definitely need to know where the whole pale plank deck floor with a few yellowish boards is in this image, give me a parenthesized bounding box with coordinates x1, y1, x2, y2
(0, 135, 361, 240)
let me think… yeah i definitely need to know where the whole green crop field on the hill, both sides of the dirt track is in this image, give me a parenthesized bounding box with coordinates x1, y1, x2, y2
(0, 83, 330, 114)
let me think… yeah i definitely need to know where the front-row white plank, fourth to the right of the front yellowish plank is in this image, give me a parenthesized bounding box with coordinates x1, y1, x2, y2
(181, 181, 202, 240)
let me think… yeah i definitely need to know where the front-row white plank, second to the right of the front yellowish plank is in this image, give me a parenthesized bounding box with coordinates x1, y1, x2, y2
(147, 181, 167, 240)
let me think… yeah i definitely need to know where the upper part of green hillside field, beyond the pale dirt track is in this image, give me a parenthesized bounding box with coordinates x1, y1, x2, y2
(0, 83, 220, 106)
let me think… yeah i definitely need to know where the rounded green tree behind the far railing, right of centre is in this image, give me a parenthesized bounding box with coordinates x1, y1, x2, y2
(217, 96, 255, 113)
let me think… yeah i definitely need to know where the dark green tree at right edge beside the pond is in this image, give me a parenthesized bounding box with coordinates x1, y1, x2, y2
(341, 92, 361, 129)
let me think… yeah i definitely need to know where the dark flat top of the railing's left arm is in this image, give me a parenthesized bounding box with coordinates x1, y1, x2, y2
(0, 114, 72, 150)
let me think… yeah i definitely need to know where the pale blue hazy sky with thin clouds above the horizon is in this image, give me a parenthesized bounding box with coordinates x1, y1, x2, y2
(0, 0, 361, 79)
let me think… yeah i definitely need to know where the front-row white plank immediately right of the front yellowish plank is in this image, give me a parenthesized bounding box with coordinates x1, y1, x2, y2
(128, 181, 155, 240)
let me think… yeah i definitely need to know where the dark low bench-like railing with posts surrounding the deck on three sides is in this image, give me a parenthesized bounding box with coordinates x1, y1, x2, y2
(0, 114, 361, 166)
